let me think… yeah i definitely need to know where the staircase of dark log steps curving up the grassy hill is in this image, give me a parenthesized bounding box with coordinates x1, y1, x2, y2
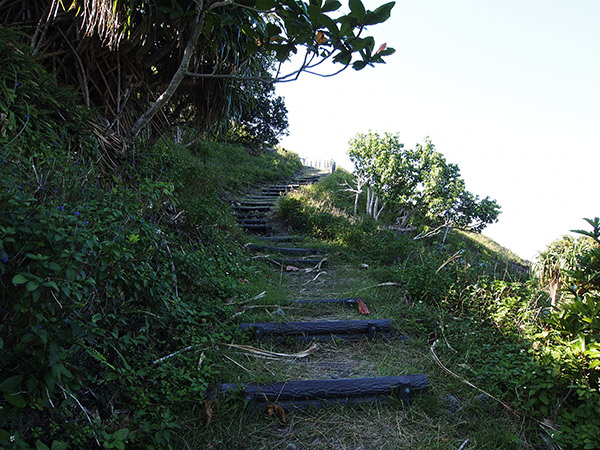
(219, 167, 428, 411)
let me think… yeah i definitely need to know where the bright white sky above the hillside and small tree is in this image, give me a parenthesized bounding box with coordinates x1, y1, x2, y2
(277, 0, 600, 259)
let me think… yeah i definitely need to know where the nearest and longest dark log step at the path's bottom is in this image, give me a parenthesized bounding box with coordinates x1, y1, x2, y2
(220, 373, 429, 411)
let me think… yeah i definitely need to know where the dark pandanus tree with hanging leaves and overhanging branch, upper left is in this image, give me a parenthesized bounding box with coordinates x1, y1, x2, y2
(0, 0, 394, 146)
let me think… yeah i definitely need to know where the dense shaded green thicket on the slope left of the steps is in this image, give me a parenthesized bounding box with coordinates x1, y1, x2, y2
(0, 33, 301, 449)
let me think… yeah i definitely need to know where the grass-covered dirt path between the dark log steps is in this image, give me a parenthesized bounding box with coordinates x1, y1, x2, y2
(197, 171, 538, 449)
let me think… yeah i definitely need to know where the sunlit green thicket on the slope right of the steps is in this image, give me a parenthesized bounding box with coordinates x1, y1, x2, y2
(278, 170, 600, 449)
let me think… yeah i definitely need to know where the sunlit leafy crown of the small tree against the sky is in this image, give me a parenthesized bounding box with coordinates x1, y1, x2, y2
(349, 132, 500, 236)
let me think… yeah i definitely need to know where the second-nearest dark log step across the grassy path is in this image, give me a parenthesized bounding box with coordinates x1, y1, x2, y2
(239, 319, 392, 341)
